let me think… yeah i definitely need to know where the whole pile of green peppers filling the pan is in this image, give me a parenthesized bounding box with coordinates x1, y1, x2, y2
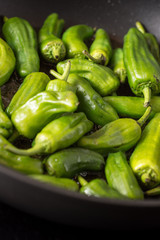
(0, 13, 160, 201)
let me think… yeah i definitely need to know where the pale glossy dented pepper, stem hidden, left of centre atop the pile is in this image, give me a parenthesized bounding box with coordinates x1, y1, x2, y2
(11, 91, 78, 139)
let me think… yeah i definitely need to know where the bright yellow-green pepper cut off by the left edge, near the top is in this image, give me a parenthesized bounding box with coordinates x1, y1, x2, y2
(0, 38, 16, 86)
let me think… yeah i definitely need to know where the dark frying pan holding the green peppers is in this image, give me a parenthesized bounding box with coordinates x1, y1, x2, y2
(0, 0, 160, 229)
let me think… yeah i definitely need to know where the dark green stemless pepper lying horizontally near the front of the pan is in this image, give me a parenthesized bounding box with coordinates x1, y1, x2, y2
(44, 147, 105, 178)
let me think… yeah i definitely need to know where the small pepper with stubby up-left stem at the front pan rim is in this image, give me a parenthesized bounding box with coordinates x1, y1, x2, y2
(78, 176, 125, 199)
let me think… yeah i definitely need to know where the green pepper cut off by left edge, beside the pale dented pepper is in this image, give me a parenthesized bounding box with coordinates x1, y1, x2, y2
(0, 89, 13, 138)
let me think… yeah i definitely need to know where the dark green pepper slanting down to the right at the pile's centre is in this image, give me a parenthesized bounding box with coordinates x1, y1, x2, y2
(67, 74, 119, 126)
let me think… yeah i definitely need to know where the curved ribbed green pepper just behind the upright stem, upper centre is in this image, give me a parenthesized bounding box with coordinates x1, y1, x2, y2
(57, 59, 120, 96)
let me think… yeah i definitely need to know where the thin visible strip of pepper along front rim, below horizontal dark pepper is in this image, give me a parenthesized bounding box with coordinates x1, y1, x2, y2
(29, 174, 79, 192)
